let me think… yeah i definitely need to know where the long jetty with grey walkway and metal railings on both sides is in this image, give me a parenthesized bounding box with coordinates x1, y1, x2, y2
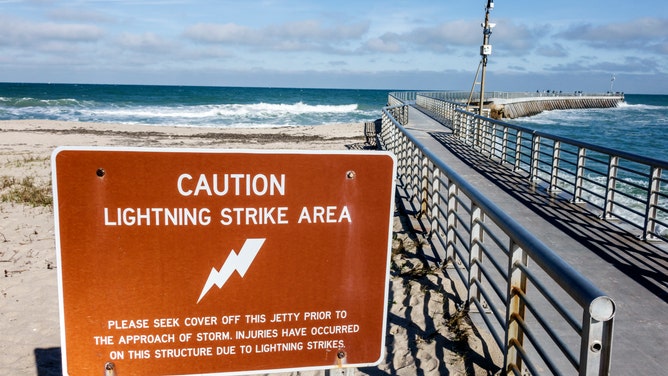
(375, 92, 668, 375)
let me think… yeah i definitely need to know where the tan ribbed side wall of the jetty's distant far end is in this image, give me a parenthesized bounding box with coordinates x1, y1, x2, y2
(489, 95, 624, 119)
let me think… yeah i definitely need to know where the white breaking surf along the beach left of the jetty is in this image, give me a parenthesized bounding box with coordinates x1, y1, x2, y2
(0, 98, 377, 127)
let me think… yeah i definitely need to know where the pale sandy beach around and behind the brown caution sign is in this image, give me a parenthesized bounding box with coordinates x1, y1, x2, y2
(0, 120, 496, 375)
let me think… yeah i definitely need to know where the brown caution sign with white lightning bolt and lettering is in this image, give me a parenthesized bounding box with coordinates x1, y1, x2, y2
(52, 148, 395, 376)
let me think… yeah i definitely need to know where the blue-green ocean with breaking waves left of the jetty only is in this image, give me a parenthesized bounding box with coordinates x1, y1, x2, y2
(0, 83, 388, 128)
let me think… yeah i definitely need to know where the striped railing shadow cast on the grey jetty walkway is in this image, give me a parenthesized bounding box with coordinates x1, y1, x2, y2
(430, 132, 668, 302)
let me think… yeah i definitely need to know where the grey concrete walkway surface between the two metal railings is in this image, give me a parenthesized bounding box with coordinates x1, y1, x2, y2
(405, 106, 668, 375)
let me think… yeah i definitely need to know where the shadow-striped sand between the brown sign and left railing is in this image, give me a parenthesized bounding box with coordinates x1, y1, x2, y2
(356, 184, 502, 376)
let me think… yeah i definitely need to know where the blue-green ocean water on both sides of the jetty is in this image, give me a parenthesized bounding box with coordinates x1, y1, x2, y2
(0, 83, 668, 160)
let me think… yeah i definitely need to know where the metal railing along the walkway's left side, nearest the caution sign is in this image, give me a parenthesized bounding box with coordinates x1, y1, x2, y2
(378, 101, 615, 375)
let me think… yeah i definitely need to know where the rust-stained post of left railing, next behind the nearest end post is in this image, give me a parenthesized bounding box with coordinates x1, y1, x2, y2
(505, 240, 528, 370)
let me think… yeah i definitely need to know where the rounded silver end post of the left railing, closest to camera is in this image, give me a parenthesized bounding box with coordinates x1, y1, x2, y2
(579, 296, 615, 376)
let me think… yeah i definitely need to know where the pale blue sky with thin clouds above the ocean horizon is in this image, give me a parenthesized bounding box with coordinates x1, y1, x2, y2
(0, 0, 668, 94)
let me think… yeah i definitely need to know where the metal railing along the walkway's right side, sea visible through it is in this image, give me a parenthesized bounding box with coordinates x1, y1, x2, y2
(416, 93, 668, 241)
